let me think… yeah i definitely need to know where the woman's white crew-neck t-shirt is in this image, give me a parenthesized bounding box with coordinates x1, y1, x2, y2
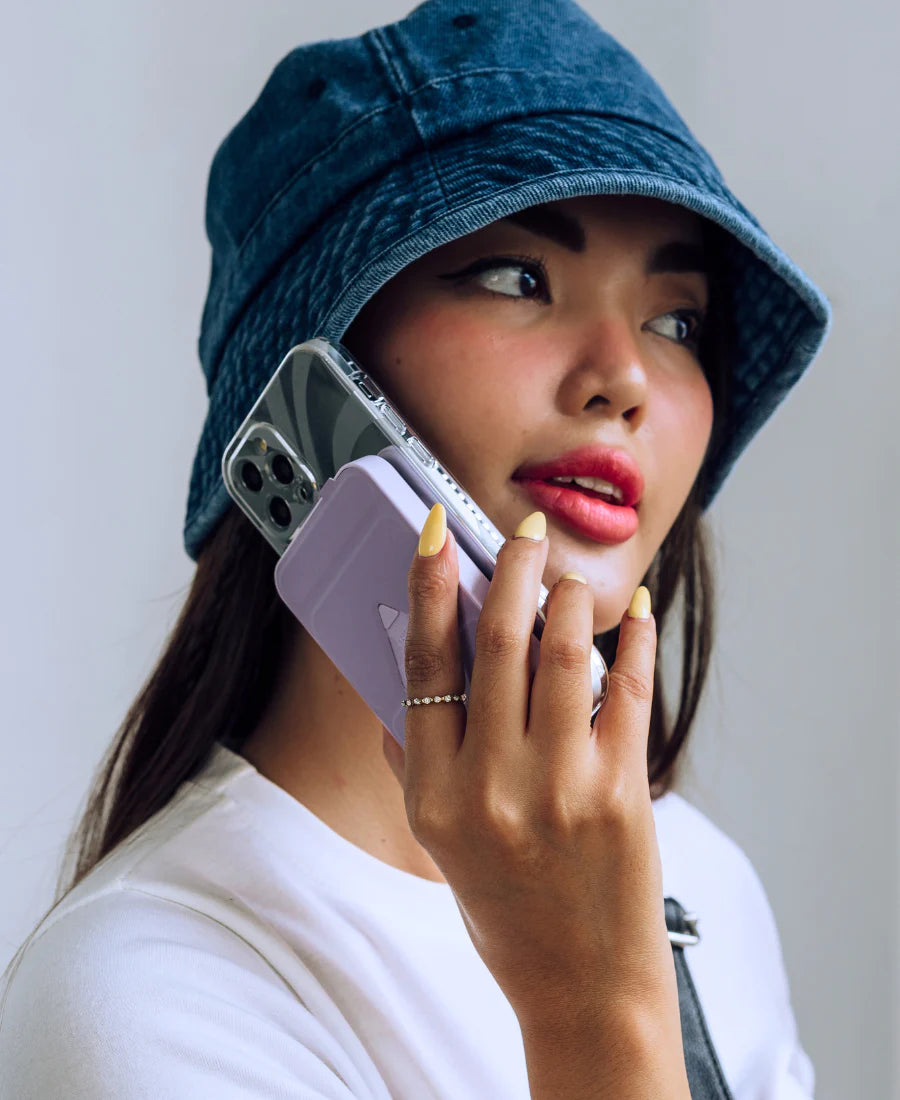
(0, 746, 813, 1100)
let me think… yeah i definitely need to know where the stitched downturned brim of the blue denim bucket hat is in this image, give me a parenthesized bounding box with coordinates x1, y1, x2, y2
(185, 112, 831, 560)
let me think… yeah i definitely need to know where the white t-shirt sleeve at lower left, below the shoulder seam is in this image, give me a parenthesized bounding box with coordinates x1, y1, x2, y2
(0, 882, 365, 1100)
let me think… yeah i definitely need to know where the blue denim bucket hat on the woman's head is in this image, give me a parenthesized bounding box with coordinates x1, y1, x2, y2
(185, 0, 831, 560)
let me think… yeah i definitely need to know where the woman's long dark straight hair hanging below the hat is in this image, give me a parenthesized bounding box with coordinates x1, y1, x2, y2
(5, 223, 734, 976)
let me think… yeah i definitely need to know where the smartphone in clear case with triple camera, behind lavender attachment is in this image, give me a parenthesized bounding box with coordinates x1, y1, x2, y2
(222, 338, 608, 739)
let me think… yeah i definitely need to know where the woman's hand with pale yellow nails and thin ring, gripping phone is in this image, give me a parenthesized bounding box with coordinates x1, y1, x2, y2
(384, 505, 681, 1056)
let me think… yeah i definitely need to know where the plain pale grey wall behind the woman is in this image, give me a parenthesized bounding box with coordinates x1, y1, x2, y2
(0, 0, 900, 1100)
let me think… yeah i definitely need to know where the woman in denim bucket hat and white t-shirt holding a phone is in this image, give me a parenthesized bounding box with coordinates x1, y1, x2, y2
(0, 0, 830, 1100)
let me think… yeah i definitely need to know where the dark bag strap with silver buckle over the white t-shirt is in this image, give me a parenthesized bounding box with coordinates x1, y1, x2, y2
(666, 898, 733, 1100)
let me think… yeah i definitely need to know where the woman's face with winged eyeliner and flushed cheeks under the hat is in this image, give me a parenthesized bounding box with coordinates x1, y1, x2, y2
(344, 196, 713, 634)
